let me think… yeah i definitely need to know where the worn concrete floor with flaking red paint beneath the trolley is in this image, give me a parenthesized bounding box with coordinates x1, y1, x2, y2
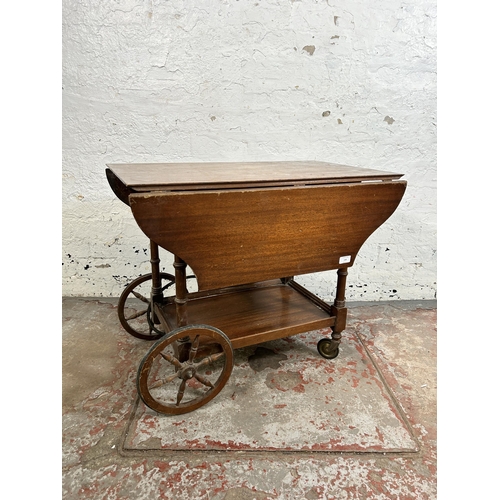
(62, 298, 437, 500)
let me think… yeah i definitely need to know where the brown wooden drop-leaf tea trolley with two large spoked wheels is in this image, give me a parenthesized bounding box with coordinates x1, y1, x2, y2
(106, 161, 406, 414)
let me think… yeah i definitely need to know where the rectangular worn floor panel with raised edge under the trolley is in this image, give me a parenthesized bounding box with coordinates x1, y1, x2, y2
(122, 329, 419, 453)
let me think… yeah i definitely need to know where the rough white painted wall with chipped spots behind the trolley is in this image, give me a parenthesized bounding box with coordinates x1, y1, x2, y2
(63, 0, 436, 300)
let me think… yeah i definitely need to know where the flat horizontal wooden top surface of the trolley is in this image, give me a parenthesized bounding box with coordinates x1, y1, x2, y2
(107, 161, 402, 192)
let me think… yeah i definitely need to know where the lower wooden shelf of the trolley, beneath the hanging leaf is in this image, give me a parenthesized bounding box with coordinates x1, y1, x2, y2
(156, 282, 335, 349)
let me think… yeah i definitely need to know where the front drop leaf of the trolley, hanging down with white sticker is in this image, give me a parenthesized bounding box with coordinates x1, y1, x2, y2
(129, 181, 406, 290)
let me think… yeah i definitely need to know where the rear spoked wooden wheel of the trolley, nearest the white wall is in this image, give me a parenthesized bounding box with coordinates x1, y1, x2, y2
(118, 273, 175, 340)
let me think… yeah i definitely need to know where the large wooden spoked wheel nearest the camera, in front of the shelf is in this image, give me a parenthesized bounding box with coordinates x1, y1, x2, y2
(137, 325, 234, 415)
